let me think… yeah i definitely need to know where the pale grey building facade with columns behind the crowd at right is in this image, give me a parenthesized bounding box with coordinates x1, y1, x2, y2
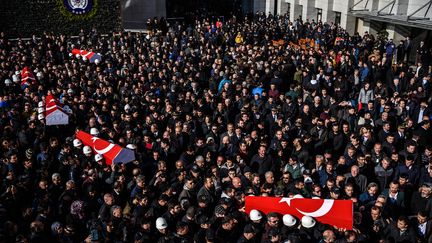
(251, 0, 432, 41)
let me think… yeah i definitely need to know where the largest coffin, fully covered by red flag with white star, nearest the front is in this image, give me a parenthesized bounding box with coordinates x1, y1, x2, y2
(246, 196, 353, 230)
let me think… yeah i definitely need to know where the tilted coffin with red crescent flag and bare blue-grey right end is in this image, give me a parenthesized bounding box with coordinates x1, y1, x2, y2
(76, 131, 135, 165)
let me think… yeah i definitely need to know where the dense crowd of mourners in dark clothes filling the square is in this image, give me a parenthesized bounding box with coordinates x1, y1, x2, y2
(0, 10, 432, 242)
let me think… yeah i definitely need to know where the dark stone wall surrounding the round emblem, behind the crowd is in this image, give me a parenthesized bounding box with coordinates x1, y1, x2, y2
(0, 0, 121, 38)
